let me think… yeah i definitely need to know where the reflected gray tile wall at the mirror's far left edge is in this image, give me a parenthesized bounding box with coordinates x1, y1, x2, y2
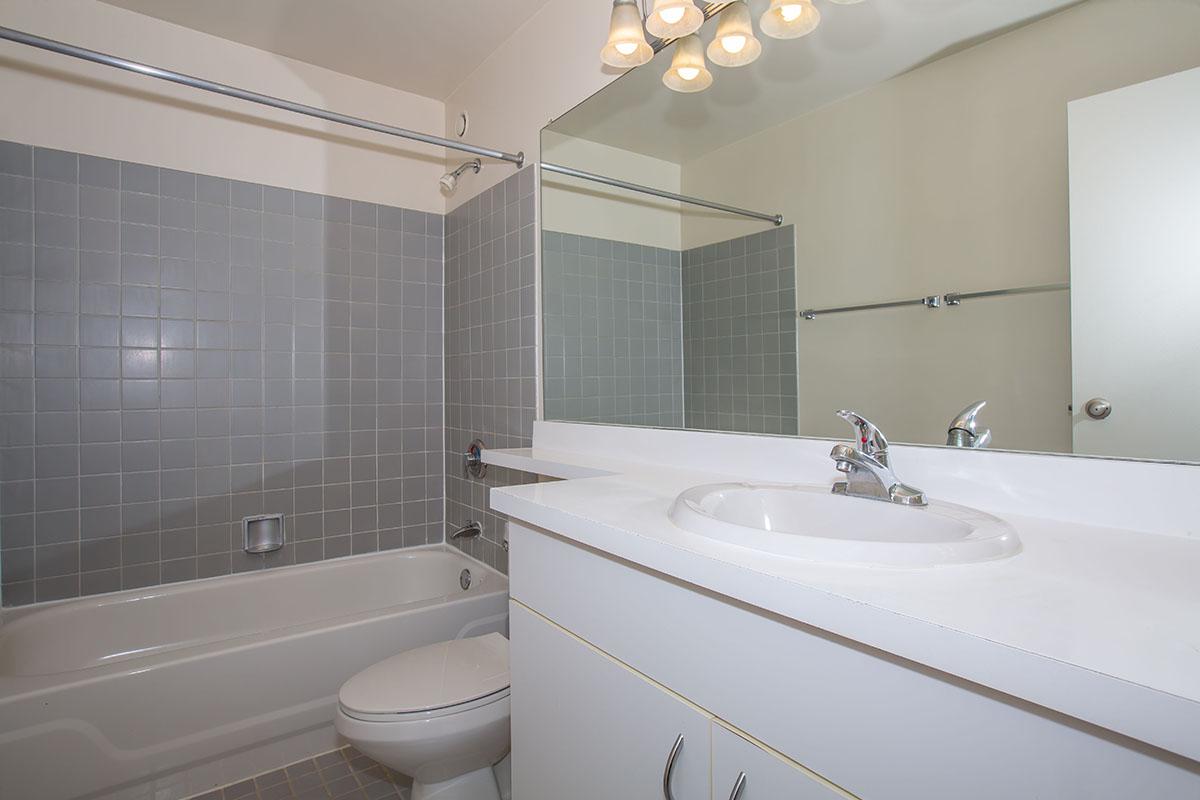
(542, 230, 684, 428)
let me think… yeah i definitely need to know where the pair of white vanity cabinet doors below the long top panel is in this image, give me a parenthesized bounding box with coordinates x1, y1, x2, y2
(509, 602, 848, 800)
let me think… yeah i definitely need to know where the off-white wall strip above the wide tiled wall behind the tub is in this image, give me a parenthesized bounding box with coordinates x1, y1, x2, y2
(0, 0, 445, 213)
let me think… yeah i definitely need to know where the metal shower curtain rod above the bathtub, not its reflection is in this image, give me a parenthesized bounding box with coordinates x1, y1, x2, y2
(0, 26, 524, 169)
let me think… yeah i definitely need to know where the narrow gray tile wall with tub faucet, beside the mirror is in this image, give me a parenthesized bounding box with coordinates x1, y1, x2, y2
(445, 167, 538, 572)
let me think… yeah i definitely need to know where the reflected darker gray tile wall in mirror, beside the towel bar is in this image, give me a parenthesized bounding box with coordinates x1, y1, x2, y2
(683, 225, 798, 434)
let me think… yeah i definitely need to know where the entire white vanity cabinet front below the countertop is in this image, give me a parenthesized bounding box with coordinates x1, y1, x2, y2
(509, 523, 1200, 800)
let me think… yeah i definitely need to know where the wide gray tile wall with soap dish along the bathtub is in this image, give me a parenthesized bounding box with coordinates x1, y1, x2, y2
(0, 143, 446, 604)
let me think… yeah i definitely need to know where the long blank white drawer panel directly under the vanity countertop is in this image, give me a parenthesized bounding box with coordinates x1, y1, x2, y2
(509, 523, 1200, 800)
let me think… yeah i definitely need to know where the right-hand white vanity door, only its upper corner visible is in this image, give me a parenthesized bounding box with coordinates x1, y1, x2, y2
(713, 722, 851, 800)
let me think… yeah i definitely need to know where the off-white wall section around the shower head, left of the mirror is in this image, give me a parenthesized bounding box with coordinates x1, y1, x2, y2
(445, 0, 620, 209)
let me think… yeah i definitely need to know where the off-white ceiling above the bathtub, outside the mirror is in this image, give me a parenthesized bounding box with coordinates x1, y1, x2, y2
(103, 0, 554, 100)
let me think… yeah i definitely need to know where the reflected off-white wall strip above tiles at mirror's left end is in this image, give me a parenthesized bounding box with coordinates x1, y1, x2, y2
(541, 131, 682, 249)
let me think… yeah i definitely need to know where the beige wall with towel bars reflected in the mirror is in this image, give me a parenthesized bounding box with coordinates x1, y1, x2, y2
(683, 0, 1200, 455)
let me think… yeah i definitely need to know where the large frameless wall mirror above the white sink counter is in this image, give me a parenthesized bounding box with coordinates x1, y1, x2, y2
(541, 0, 1200, 461)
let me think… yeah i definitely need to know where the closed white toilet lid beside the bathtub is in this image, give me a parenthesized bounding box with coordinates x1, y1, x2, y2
(337, 633, 509, 715)
